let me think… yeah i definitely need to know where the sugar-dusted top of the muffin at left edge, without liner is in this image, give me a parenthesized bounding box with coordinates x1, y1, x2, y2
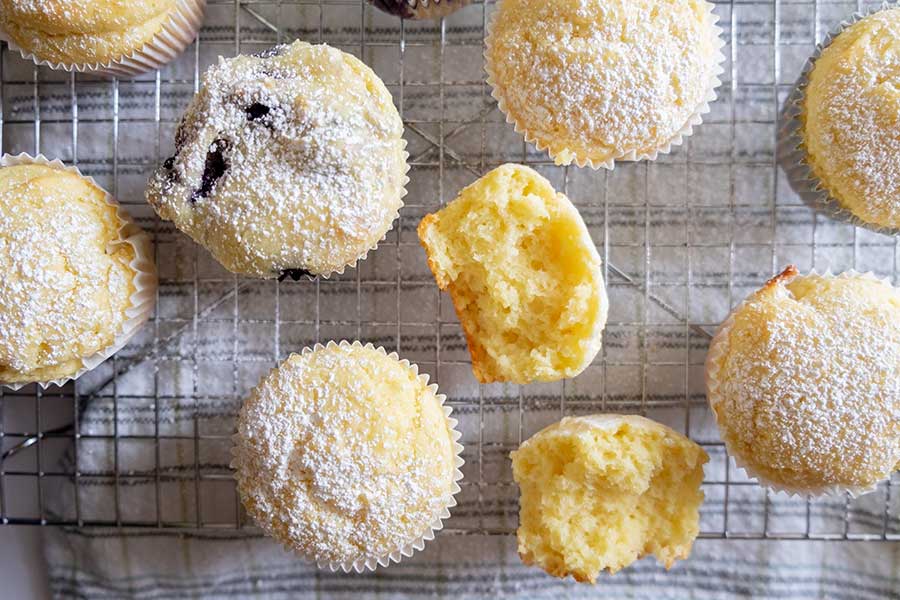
(0, 165, 136, 383)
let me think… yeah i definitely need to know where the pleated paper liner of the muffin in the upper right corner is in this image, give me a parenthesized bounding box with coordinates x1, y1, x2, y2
(778, 2, 900, 236)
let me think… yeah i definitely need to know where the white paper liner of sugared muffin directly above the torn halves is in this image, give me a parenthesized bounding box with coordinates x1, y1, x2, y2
(484, 3, 725, 171)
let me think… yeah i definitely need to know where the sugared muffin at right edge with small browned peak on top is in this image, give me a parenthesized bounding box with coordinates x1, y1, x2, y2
(706, 266, 900, 494)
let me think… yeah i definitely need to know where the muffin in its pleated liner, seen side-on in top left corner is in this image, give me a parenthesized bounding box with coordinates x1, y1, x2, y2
(0, 0, 206, 74)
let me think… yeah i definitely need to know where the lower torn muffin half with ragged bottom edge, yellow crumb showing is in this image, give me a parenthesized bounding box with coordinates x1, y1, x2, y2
(512, 415, 709, 583)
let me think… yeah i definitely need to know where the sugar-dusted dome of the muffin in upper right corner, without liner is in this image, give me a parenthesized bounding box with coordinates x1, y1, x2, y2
(801, 8, 900, 229)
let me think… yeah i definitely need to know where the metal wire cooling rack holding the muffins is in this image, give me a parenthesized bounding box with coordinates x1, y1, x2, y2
(0, 0, 900, 540)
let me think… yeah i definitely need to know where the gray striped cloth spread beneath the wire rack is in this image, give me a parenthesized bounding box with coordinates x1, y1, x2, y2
(2, 2, 900, 600)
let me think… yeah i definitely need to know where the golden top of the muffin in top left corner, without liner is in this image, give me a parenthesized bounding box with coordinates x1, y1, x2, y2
(0, 0, 177, 64)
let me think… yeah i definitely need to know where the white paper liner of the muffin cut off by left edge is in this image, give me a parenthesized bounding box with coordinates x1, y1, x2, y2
(0, 152, 158, 390)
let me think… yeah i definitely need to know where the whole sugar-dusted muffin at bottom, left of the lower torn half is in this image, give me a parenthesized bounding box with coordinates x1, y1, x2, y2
(232, 342, 462, 571)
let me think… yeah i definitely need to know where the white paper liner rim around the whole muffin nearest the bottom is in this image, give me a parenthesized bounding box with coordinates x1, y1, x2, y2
(229, 340, 465, 573)
